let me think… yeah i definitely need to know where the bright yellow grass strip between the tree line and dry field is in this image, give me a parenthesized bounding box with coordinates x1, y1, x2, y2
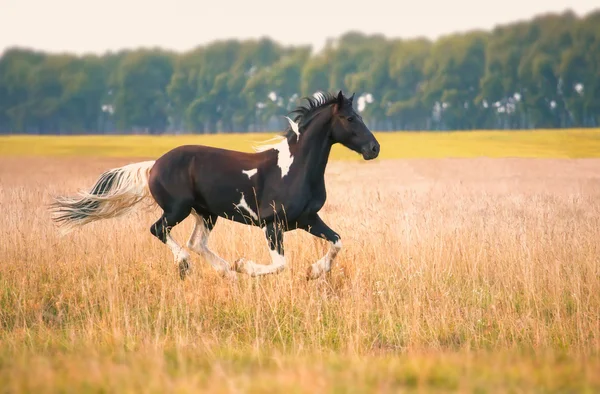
(0, 129, 600, 160)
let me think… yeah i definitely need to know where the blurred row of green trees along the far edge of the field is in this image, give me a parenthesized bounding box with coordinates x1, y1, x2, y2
(0, 10, 600, 134)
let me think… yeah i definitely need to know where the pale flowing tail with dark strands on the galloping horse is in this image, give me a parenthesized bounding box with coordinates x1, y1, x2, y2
(50, 160, 154, 234)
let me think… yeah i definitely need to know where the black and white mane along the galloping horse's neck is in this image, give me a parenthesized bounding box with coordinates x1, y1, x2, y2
(254, 91, 337, 152)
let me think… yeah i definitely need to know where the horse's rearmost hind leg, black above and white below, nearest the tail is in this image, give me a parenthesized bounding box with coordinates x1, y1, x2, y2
(150, 205, 191, 279)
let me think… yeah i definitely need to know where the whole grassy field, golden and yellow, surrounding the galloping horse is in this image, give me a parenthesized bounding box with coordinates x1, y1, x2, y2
(0, 130, 600, 393)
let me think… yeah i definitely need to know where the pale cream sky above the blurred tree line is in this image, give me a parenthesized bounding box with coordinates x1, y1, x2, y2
(0, 0, 600, 54)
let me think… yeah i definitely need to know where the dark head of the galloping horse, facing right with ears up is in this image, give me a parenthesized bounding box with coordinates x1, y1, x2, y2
(331, 90, 379, 160)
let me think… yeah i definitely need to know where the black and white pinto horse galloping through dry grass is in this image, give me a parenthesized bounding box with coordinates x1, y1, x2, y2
(50, 90, 380, 280)
